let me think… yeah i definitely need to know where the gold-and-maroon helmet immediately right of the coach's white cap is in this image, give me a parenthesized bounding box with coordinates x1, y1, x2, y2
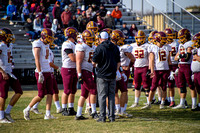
(110, 30, 125, 46)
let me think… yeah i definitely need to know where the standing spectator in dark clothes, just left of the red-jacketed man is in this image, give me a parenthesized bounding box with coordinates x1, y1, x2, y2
(52, 1, 62, 27)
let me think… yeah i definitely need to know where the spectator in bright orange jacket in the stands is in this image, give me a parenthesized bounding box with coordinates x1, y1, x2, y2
(111, 6, 123, 25)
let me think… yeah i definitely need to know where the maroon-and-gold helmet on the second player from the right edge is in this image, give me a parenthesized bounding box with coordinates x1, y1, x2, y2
(178, 29, 191, 44)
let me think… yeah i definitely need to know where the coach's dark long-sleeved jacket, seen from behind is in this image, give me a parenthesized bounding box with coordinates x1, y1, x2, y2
(92, 40, 120, 79)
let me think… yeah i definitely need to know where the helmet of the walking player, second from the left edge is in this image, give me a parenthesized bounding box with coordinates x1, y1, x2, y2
(40, 28, 54, 44)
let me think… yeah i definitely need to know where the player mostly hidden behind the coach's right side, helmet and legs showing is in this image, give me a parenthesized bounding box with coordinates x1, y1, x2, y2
(110, 30, 130, 117)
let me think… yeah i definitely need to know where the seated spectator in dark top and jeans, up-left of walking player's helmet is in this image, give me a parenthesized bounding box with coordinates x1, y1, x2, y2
(24, 18, 37, 41)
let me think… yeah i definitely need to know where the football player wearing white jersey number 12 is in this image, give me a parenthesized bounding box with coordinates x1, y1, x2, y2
(142, 32, 171, 109)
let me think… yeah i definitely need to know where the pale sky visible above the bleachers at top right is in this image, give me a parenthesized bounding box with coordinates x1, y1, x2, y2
(123, 0, 200, 12)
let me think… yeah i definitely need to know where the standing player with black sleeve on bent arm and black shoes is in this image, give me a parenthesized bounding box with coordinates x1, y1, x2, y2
(61, 27, 78, 116)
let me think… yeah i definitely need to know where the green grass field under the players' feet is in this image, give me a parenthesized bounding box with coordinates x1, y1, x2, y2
(0, 89, 200, 133)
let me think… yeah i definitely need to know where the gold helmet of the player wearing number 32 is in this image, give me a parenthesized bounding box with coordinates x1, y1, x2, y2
(135, 30, 146, 46)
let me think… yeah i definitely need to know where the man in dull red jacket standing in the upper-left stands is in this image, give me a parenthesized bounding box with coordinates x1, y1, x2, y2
(61, 5, 72, 28)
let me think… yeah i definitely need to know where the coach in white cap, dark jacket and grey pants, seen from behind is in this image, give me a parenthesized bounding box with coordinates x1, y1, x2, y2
(92, 31, 120, 122)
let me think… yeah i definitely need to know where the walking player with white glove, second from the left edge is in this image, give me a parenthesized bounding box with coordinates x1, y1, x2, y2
(23, 28, 56, 120)
